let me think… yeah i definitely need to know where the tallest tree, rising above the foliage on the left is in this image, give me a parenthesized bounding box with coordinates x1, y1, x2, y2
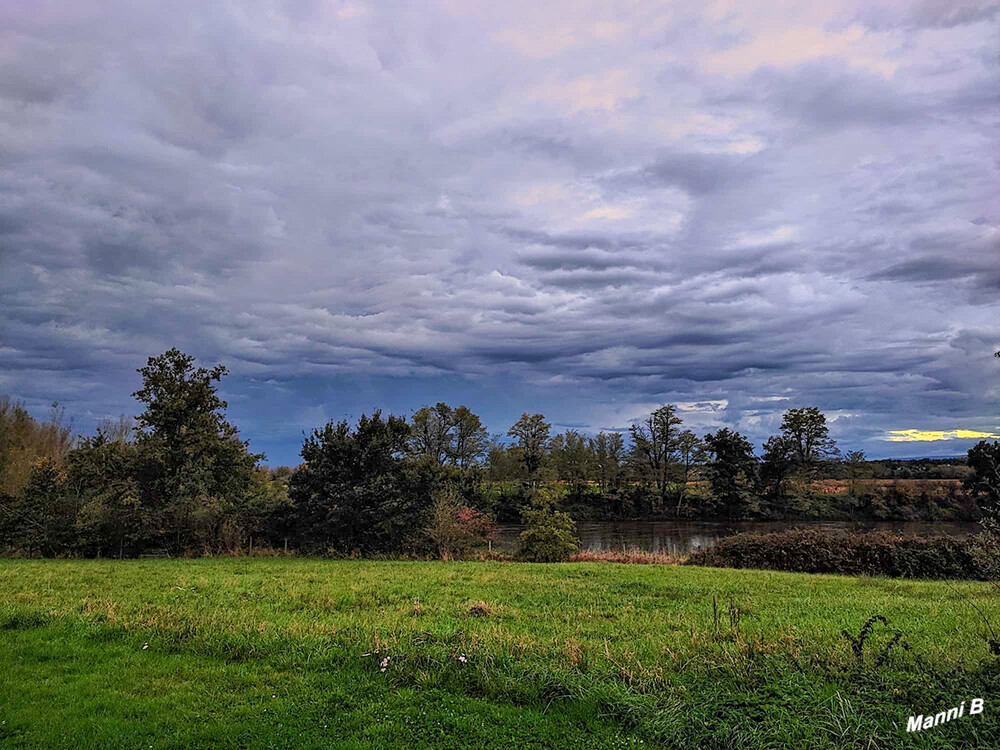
(132, 348, 264, 550)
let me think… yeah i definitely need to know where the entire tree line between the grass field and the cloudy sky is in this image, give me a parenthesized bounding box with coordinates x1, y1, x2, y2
(0, 349, 1000, 557)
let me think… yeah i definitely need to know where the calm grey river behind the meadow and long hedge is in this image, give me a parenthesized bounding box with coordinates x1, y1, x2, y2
(499, 521, 979, 556)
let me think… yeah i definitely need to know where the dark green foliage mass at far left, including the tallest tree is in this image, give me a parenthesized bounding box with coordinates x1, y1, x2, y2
(0, 349, 272, 557)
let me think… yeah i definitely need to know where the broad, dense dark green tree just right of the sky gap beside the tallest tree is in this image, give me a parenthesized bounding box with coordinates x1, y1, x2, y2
(288, 411, 431, 553)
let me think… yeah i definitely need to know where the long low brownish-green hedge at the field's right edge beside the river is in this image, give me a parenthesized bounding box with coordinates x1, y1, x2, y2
(687, 529, 985, 580)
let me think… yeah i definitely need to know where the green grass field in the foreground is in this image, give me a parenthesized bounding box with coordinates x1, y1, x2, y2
(0, 558, 1000, 750)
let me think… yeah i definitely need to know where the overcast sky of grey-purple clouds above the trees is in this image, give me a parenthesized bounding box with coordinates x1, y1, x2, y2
(0, 0, 1000, 464)
